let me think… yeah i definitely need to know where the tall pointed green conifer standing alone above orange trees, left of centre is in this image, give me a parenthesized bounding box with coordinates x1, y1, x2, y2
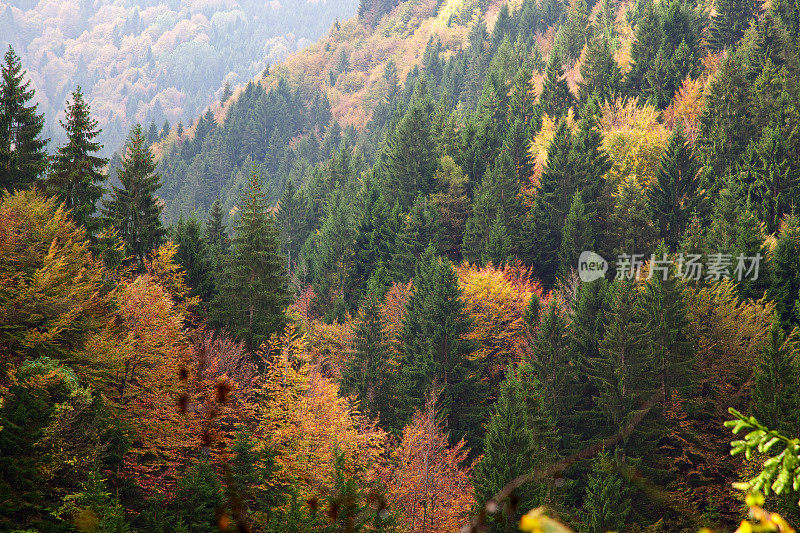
(211, 168, 289, 356)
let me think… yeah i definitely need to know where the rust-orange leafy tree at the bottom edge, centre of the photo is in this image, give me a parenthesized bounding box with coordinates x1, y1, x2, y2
(384, 395, 475, 533)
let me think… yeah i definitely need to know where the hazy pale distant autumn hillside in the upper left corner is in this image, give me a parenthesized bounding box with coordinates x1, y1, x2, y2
(0, 0, 357, 155)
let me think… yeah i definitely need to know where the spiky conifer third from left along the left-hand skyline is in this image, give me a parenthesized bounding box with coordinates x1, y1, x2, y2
(104, 124, 165, 265)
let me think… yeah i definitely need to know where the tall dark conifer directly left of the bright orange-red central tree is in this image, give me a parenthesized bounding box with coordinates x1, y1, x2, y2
(397, 246, 482, 445)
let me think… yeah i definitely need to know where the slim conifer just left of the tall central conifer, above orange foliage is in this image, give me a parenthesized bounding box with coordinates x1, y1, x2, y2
(342, 291, 392, 420)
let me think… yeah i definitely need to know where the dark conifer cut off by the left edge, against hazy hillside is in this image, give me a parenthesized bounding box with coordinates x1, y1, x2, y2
(0, 46, 48, 191)
